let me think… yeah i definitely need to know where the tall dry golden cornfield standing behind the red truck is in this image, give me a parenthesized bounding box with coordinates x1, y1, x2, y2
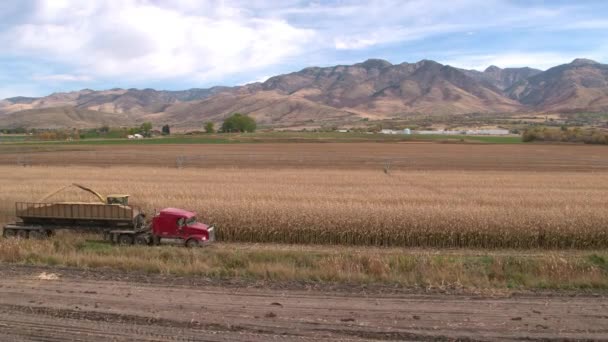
(0, 166, 608, 249)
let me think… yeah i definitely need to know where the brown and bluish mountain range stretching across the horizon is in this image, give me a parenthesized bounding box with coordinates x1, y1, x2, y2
(0, 59, 608, 129)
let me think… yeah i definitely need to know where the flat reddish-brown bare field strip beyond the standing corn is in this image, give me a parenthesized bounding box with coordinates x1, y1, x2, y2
(0, 142, 608, 171)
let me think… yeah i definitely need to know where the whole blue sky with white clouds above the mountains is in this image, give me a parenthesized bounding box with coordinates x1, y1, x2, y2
(0, 0, 608, 98)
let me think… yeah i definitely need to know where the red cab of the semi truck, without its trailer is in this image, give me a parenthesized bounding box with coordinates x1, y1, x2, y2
(151, 208, 215, 245)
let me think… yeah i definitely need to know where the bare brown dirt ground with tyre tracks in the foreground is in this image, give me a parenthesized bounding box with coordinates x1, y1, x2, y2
(0, 265, 608, 341)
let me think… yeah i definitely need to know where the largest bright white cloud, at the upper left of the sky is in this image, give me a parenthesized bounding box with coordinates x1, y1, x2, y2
(0, 0, 314, 81)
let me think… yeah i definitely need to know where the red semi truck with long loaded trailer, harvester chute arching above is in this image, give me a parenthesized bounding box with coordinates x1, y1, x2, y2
(3, 184, 215, 247)
